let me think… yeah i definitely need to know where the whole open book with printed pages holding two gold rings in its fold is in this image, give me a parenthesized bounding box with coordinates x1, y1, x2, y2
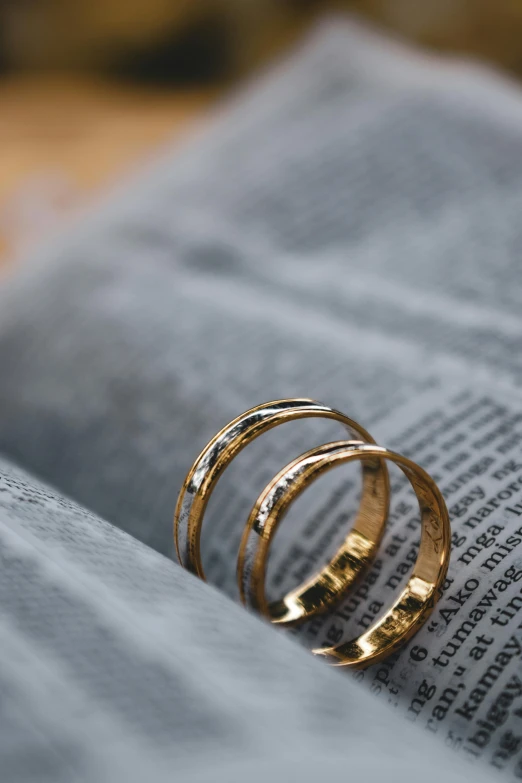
(0, 20, 522, 783)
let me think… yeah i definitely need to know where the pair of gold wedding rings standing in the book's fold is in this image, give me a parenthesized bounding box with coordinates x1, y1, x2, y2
(174, 399, 450, 666)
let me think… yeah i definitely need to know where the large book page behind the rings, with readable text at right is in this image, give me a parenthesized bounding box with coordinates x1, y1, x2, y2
(0, 16, 522, 778)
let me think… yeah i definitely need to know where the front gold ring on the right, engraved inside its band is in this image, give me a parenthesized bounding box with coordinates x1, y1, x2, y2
(238, 441, 450, 666)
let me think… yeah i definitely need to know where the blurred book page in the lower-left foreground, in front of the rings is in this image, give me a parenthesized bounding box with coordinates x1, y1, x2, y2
(0, 460, 485, 783)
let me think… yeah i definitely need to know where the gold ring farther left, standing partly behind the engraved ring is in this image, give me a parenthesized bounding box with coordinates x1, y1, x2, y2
(174, 398, 389, 624)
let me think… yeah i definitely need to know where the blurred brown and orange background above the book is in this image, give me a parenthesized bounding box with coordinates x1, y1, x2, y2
(0, 0, 522, 268)
